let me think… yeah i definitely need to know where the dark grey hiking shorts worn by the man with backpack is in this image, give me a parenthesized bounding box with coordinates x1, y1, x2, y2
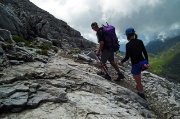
(101, 50, 114, 64)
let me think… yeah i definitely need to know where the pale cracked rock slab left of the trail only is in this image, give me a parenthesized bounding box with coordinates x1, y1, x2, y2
(0, 56, 156, 119)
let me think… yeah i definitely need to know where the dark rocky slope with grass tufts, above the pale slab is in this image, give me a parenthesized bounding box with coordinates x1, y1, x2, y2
(0, 0, 95, 70)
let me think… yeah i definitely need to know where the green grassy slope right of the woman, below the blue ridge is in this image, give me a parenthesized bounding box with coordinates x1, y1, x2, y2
(149, 42, 180, 81)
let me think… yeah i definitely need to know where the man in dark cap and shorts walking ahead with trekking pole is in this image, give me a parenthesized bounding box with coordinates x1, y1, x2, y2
(91, 22, 124, 81)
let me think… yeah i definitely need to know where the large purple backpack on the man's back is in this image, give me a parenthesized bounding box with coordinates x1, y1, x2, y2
(102, 22, 120, 52)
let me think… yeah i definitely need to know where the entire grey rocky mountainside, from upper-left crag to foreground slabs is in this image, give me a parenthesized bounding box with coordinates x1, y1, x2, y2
(0, 0, 180, 119)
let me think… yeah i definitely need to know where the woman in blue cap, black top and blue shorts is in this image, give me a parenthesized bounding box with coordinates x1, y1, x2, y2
(121, 27, 149, 99)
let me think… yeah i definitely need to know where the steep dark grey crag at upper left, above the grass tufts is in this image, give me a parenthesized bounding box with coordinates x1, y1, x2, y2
(0, 0, 95, 49)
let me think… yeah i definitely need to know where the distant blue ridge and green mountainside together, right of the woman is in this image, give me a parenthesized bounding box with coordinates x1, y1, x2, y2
(146, 35, 180, 82)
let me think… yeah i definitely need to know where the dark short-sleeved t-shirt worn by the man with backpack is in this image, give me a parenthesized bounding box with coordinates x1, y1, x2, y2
(96, 27, 107, 51)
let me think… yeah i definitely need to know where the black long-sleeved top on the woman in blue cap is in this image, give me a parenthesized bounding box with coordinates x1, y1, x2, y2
(122, 39, 148, 65)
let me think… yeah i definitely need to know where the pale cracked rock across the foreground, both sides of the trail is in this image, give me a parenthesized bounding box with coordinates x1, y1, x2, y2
(0, 53, 180, 119)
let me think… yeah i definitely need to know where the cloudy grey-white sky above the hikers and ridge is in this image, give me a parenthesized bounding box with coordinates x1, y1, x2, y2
(30, 0, 180, 43)
